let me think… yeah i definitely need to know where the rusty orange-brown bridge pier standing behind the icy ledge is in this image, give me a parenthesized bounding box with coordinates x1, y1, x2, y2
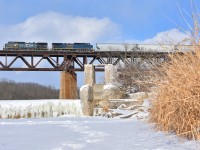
(59, 71, 77, 99)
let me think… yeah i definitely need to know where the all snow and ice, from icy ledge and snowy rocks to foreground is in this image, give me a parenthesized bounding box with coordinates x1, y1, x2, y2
(0, 100, 200, 150)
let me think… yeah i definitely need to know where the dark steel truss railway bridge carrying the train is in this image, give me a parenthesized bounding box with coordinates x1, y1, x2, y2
(0, 50, 169, 72)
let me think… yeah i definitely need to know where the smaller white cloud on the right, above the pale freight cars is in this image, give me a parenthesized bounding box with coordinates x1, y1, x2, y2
(142, 29, 191, 44)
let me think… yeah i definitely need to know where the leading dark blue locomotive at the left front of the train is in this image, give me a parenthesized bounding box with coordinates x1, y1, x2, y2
(3, 41, 48, 50)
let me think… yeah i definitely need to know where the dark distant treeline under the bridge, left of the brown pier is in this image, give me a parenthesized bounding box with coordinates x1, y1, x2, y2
(0, 80, 59, 100)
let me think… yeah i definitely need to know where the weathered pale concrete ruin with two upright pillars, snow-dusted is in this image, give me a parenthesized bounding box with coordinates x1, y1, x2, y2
(80, 64, 120, 116)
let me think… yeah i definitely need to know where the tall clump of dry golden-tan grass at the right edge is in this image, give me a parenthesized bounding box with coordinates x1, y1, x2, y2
(150, 46, 200, 139)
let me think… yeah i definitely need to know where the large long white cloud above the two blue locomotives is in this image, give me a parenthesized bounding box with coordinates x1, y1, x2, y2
(0, 12, 119, 47)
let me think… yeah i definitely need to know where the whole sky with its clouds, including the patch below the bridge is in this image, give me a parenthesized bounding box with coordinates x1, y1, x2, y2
(0, 0, 200, 88)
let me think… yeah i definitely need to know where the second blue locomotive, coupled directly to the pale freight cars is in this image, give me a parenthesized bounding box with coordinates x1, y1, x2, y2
(52, 43, 93, 51)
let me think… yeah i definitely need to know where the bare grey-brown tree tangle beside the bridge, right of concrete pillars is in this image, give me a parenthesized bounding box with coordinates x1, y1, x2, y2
(115, 44, 164, 93)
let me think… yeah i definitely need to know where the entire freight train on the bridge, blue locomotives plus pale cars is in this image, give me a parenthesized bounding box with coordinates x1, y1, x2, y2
(3, 41, 189, 52)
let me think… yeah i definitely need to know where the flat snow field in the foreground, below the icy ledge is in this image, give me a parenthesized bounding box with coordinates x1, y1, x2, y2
(0, 117, 200, 150)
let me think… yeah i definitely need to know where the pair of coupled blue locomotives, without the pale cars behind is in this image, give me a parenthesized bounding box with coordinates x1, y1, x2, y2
(3, 41, 93, 51)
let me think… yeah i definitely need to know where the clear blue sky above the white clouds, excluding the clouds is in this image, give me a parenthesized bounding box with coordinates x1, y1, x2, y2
(0, 0, 197, 40)
